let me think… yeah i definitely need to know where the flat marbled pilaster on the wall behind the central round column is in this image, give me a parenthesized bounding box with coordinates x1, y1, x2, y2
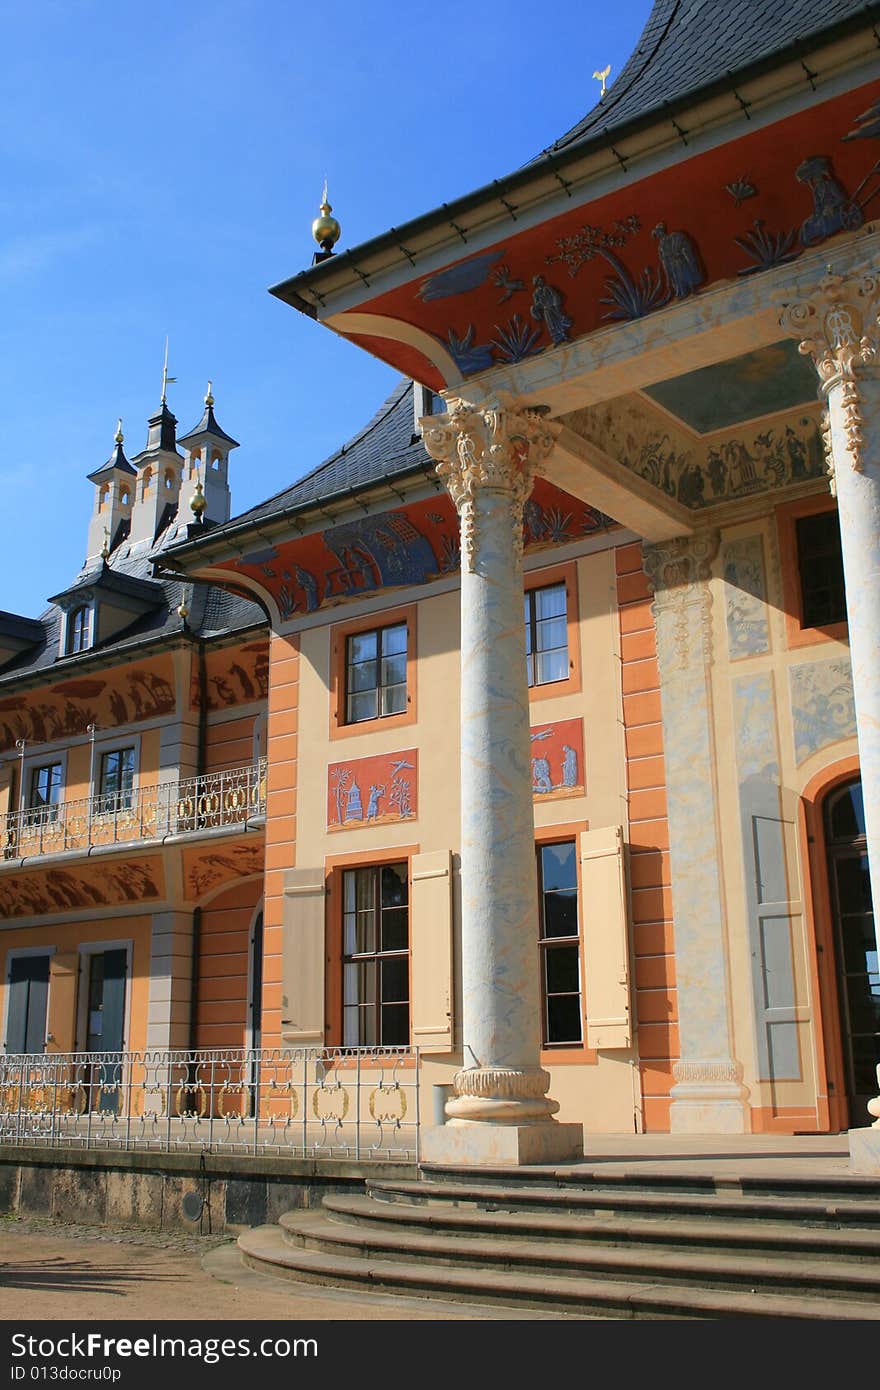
(644, 531, 749, 1134)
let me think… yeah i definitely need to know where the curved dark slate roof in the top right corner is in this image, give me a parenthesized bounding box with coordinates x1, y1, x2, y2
(538, 0, 880, 158)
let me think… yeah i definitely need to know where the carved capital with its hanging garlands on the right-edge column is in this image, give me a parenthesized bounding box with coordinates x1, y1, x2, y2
(780, 267, 880, 480)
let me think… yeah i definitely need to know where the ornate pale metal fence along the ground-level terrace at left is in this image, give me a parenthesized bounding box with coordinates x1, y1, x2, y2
(0, 1047, 418, 1162)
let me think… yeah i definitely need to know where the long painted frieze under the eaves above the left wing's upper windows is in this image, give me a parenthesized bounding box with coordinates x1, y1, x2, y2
(0, 656, 175, 752)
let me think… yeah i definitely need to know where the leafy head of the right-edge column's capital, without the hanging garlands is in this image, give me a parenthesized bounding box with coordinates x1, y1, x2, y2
(780, 265, 880, 393)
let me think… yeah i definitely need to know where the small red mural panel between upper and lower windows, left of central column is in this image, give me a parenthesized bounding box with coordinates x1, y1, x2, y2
(327, 748, 418, 830)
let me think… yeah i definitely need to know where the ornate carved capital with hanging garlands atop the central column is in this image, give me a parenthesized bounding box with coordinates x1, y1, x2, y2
(420, 400, 557, 569)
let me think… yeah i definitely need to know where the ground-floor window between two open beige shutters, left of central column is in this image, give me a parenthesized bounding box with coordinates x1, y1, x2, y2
(342, 863, 410, 1047)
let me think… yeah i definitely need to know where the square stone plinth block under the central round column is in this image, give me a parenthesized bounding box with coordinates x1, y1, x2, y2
(420, 1120, 584, 1168)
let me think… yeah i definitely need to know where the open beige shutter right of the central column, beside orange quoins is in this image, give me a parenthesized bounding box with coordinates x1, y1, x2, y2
(580, 826, 633, 1048)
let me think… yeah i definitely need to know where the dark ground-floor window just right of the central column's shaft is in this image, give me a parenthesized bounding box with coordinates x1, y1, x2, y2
(538, 840, 584, 1047)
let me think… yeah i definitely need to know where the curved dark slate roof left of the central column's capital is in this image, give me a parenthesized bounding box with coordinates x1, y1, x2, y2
(183, 379, 434, 539)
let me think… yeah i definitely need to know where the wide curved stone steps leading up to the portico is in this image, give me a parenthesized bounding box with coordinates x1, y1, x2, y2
(239, 1168, 880, 1319)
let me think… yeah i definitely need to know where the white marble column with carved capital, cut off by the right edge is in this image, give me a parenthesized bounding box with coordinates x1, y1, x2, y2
(780, 267, 880, 1172)
